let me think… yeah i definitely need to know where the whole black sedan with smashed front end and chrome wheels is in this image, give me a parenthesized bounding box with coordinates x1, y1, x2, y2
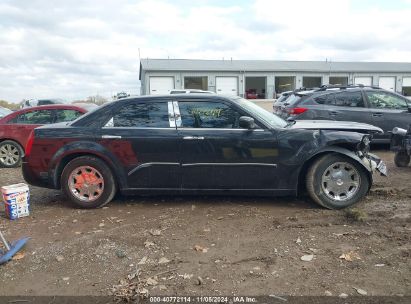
(23, 94, 385, 209)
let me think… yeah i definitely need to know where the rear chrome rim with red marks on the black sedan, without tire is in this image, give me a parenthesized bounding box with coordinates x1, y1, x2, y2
(68, 166, 104, 202)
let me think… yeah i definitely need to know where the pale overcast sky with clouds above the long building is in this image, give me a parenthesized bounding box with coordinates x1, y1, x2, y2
(0, 0, 411, 102)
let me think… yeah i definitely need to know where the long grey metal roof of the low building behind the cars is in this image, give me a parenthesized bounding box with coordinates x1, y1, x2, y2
(140, 59, 411, 74)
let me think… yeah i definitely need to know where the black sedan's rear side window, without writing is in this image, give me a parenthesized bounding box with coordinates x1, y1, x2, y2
(106, 102, 170, 128)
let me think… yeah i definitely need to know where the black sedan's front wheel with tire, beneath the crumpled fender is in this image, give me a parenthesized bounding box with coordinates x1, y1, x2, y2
(306, 154, 370, 209)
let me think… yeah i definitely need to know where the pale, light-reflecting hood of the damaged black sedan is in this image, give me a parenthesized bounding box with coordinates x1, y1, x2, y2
(290, 120, 384, 133)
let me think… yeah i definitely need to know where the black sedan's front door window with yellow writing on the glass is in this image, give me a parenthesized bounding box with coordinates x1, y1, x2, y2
(178, 101, 241, 129)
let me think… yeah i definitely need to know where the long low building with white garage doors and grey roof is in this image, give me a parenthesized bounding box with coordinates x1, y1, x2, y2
(140, 59, 411, 98)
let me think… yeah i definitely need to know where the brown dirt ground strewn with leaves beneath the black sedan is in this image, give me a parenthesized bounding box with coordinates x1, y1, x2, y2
(0, 150, 411, 296)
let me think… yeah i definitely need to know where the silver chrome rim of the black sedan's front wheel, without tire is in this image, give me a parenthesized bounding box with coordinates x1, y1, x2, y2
(321, 162, 361, 202)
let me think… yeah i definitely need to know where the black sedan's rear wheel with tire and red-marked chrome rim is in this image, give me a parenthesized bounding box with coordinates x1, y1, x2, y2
(61, 156, 117, 208)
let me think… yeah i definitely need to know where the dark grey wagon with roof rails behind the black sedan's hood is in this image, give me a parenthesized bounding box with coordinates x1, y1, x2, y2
(277, 86, 411, 143)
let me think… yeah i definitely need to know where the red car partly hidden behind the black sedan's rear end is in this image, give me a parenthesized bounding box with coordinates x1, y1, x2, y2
(0, 104, 87, 168)
